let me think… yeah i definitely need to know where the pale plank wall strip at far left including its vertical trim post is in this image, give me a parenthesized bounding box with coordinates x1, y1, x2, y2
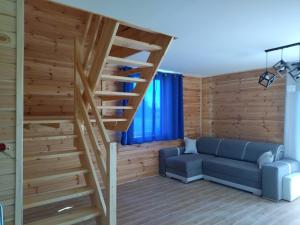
(0, 0, 24, 225)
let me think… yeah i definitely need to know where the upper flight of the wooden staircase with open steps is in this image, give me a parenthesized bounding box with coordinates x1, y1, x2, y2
(75, 15, 173, 131)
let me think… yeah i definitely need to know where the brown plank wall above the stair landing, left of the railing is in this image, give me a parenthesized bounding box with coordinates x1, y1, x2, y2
(24, 0, 87, 115)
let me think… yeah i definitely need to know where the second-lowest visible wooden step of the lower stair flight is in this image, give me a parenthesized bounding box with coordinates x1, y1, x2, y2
(24, 187, 94, 209)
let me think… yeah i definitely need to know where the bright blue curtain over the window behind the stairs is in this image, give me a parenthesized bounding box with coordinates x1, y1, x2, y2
(121, 69, 184, 145)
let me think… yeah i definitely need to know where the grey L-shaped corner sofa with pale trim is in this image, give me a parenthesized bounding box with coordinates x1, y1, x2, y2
(159, 137, 300, 200)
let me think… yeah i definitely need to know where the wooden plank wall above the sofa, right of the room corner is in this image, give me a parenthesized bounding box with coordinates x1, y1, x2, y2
(202, 70, 285, 143)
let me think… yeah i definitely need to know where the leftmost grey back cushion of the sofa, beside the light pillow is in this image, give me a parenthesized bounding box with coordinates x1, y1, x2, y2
(197, 137, 221, 155)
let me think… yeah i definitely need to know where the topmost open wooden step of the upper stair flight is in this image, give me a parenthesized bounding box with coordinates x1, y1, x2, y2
(113, 36, 161, 52)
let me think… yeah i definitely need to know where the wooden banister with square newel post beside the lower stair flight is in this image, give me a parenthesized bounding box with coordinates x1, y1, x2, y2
(74, 36, 117, 225)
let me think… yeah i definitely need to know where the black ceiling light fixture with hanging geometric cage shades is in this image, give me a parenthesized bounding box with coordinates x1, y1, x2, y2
(258, 42, 300, 87)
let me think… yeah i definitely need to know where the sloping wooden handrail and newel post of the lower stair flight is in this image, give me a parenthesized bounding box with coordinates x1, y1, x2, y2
(74, 36, 117, 225)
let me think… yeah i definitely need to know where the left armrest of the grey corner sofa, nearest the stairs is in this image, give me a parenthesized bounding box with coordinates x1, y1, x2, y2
(159, 147, 184, 176)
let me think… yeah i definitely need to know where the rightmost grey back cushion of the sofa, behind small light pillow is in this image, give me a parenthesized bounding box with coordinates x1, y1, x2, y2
(243, 142, 281, 162)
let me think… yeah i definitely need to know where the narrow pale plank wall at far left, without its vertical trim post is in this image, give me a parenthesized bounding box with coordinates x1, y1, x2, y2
(0, 0, 17, 224)
